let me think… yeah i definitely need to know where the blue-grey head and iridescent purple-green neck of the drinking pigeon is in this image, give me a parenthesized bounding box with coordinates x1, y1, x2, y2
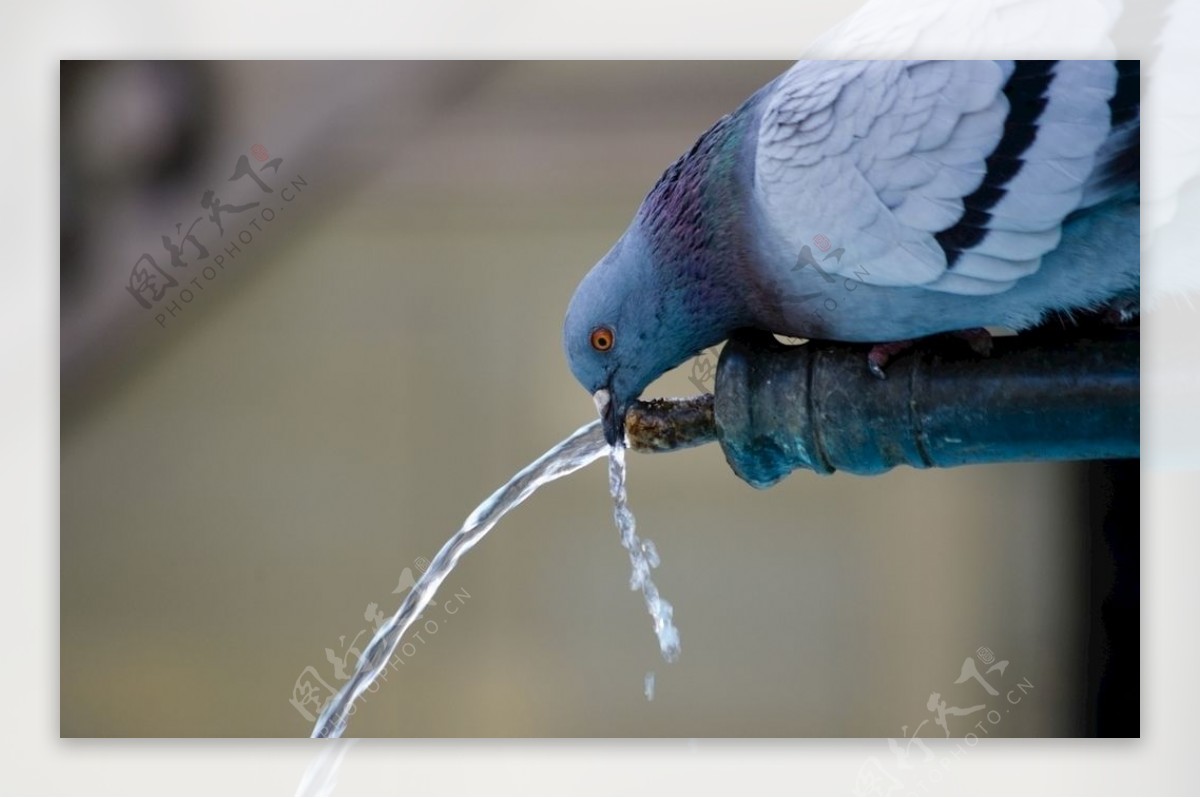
(563, 111, 746, 445)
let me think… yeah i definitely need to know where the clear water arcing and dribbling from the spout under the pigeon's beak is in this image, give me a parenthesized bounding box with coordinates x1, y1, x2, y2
(312, 421, 679, 737)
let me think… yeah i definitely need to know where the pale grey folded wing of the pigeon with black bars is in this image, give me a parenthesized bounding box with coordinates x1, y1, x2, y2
(751, 61, 1136, 294)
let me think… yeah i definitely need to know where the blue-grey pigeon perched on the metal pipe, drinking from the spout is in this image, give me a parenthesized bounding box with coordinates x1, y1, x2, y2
(563, 61, 1140, 446)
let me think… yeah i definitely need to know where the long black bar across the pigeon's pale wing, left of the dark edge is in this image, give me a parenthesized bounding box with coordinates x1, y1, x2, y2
(934, 61, 1057, 269)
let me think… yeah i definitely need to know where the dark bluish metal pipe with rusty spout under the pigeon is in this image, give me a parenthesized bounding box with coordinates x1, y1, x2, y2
(626, 331, 1139, 487)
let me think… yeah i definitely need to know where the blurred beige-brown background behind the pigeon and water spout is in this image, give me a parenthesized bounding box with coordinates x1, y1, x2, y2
(60, 59, 1138, 739)
